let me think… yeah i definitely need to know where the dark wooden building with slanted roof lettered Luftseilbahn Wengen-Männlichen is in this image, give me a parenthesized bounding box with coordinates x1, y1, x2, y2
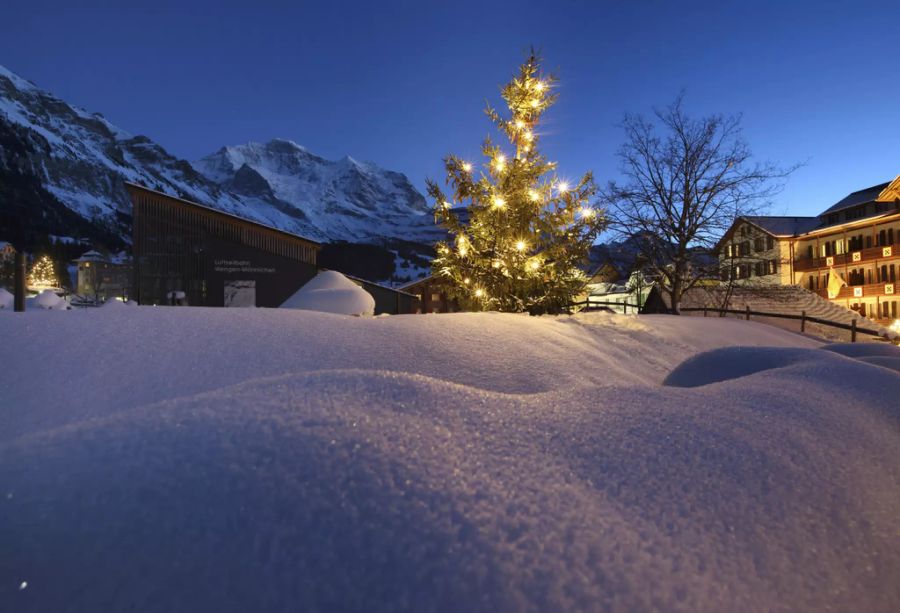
(126, 183, 320, 307)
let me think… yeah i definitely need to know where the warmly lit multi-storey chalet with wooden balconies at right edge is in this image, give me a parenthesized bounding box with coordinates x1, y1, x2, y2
(716, 176, 900, 321)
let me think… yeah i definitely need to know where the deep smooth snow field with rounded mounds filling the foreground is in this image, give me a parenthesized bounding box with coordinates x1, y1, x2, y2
(0, 306, 900, 613)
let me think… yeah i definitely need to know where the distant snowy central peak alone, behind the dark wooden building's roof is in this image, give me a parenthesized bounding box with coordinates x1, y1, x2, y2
(193, 139, 440, 242)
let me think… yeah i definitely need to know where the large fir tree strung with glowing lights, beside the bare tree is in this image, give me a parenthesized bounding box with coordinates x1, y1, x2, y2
(428, 54, 606, 313)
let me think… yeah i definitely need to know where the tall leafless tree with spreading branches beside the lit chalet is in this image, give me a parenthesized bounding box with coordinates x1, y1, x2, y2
(603, 95, 796, 313)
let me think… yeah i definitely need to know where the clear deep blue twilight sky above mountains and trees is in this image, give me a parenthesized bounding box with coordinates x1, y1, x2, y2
(0, 0, 900, 215)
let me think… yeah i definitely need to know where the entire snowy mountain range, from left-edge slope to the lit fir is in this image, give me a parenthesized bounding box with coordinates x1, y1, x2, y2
(0, 66, 440, 243)
